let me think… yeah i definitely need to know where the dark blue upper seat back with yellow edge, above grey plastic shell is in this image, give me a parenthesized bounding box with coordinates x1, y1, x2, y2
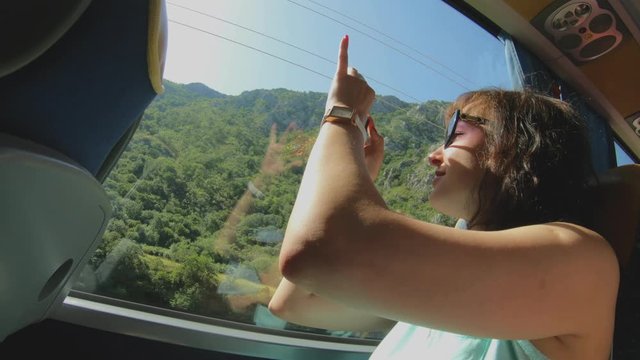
(0, 0, 168, 180)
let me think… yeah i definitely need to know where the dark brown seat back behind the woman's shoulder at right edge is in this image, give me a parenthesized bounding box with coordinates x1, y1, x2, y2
(591, 164, 640, 268)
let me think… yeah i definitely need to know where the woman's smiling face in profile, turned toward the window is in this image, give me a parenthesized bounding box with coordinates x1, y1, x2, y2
(428, 104, 485, 220)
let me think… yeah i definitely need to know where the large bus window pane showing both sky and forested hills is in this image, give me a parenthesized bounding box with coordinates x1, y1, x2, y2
(75, 0, 510, 338)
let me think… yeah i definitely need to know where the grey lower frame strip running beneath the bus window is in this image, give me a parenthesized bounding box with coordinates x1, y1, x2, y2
(56, 290, 379, 360)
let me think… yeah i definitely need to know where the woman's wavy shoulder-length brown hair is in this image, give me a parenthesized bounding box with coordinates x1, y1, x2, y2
(447, 89, 594, 230)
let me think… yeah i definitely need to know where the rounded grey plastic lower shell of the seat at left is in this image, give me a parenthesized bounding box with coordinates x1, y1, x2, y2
(0, 133, 111, 342)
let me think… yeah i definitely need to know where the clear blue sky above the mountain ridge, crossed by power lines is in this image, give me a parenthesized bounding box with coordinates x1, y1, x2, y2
(164, 0, 510, 102)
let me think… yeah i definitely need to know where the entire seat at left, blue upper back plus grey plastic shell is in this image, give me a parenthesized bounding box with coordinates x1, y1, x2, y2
(0, 0, 168, 341)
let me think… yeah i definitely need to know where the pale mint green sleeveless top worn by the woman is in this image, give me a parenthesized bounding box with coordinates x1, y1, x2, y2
(369, 322, 548, 360)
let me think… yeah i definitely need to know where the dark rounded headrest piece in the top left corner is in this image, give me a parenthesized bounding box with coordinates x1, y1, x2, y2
(0, 0, 91, 77)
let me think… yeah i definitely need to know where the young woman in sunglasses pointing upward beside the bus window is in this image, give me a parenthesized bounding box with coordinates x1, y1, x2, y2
(270, 37, 619, 360)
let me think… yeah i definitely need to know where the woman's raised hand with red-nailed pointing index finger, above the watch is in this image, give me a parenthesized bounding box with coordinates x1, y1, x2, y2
(326, 35, 376, 120)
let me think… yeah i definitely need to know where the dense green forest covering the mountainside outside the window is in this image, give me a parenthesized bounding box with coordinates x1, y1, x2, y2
(75, 81, 453, 338)
